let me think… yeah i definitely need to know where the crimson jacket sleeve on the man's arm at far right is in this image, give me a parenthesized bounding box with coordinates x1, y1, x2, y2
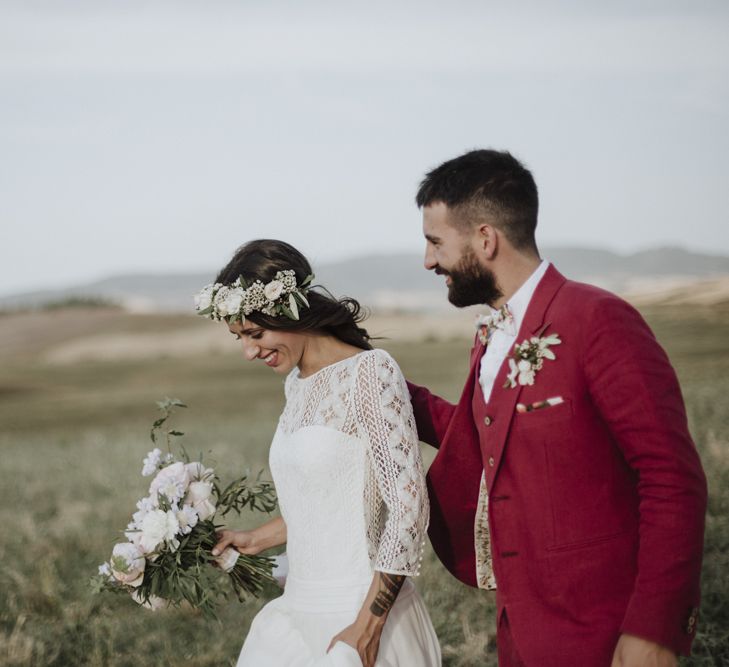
(582, 295, 707, 654)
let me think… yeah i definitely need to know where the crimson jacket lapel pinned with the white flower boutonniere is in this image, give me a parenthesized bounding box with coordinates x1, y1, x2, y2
(479, 264, 566, 489)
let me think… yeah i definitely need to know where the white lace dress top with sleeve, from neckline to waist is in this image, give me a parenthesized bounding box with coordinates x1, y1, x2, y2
(271, 350, 429, 576)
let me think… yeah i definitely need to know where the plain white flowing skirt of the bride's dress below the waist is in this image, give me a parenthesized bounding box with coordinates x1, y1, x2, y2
(238, 577, 441, 667)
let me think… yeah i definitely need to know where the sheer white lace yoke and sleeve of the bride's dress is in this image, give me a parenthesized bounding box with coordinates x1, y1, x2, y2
(277, 350, 429, 576)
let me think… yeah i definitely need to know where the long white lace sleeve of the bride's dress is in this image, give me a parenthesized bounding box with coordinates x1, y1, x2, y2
(354, 350, 429, 576)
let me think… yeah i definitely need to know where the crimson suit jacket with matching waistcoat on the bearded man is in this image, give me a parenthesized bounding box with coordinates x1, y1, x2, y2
(409, 266, 706, 667)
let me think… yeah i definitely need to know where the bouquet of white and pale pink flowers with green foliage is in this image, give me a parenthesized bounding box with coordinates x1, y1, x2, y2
(93, 399, 276, 616)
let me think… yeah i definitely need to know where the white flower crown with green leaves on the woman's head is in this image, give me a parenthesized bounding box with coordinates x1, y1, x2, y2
(195, 269, 314, 323)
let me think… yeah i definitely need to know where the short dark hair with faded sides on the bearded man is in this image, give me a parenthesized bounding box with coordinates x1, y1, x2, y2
(415, 149, 539, 250)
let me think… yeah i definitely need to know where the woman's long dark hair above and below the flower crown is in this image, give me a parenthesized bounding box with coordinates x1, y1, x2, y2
(215, 239, 372, 350)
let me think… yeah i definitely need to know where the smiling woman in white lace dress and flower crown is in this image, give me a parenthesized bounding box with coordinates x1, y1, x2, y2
(197, 240, 440, 667)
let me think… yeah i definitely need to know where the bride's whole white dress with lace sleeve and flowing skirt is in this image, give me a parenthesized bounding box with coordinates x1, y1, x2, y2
(238, 350, 441, 667)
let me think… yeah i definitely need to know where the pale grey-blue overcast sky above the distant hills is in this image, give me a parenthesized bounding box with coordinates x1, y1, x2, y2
(0, 0, 729, 294)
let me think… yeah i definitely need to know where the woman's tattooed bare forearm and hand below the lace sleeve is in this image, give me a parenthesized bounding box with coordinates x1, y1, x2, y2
(327, 572, 405, 667)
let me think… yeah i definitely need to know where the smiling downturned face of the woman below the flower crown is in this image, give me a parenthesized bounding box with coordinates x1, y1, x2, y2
(228, 321, 306, 375)
